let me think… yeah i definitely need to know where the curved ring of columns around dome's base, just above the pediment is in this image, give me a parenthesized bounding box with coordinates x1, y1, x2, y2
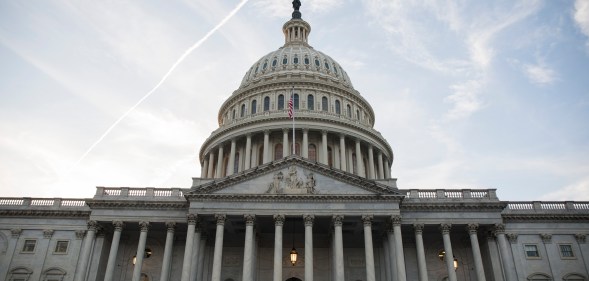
(201, 128, 391, 179)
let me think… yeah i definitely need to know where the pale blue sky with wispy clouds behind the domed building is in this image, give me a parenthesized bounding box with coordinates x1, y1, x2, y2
(0, 0, 589, 201)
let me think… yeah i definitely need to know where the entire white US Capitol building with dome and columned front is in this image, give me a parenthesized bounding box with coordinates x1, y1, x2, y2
(0, 1, 589, 281)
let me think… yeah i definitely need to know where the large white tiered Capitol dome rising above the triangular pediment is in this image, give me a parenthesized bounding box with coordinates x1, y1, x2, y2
(199, 5, 393, 179)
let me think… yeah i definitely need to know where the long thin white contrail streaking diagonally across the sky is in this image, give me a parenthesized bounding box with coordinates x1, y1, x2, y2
(68, 0, 248, 172)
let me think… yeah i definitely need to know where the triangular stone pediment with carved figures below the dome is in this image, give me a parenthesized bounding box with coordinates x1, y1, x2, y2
(187, 156, 401, 196)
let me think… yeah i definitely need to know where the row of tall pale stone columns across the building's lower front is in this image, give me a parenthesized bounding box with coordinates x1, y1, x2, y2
(74, 214, 516, 281)
